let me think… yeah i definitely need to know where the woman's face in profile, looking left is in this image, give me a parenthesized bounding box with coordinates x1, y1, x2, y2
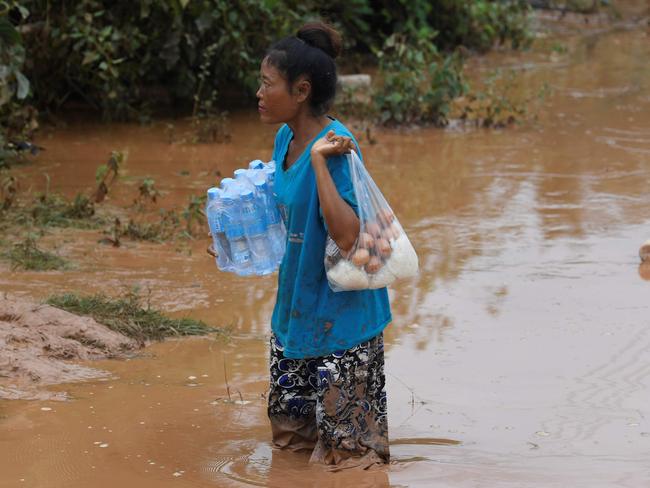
(256, 59, 305, 124)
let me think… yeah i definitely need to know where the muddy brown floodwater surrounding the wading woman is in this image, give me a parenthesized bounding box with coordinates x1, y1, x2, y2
(0, 5, 650, 488)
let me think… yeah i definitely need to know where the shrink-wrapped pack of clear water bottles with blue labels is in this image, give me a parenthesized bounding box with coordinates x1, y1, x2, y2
(206, 160, 287, 276)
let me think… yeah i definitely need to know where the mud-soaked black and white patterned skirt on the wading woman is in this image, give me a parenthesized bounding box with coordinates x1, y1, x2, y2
(268, 334, 390, 469)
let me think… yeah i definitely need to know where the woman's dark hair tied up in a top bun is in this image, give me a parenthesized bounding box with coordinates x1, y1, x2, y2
(265, 22, 341, 116)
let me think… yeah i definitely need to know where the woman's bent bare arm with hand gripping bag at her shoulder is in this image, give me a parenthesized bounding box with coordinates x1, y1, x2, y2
(311, 131, 360, 252)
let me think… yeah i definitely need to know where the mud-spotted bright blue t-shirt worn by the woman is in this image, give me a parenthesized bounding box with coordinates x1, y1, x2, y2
(271, 120, 392, 358)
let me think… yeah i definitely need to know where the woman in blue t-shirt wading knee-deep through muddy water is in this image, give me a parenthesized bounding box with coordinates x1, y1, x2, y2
(210, 23, 392, 467)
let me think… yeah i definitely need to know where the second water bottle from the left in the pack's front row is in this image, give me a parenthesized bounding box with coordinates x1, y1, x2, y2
(221, 192, 254, 276)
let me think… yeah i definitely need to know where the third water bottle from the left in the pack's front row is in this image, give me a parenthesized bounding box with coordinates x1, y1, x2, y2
(241, 190, 275, 275)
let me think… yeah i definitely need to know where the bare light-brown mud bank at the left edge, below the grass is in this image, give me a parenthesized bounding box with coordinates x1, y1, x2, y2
(0, 295, 140, 400)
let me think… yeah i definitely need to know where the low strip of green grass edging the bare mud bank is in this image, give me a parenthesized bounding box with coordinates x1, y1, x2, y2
(47, 292, 219, 342)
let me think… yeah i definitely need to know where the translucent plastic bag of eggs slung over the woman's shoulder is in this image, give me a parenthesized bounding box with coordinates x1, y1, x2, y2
(325, 151, 418, 291)
